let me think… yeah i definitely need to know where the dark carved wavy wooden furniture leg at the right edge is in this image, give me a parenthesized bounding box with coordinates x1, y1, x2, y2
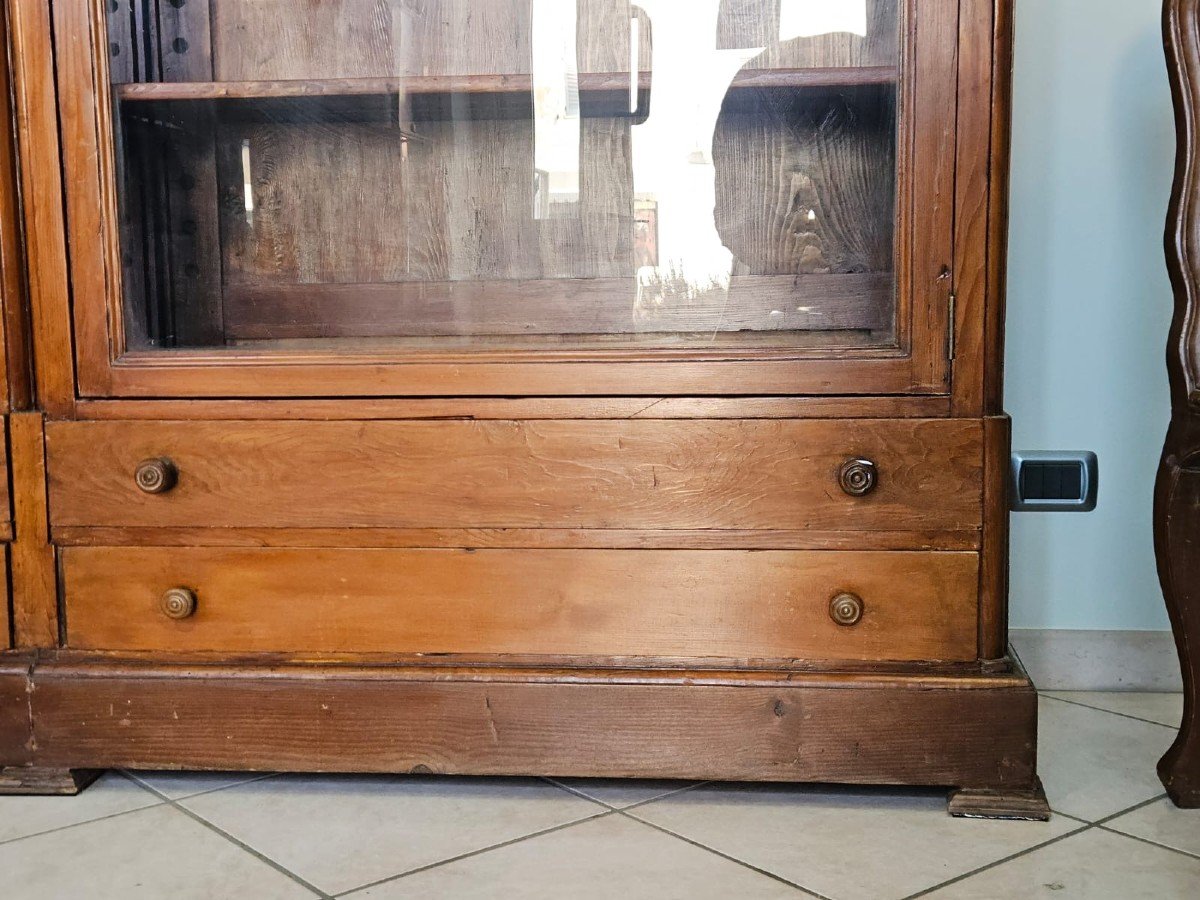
(1154, 0, 1200, 808)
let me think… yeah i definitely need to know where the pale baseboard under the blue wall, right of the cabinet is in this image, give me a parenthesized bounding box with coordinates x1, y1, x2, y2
(1009, 629, 1183, 692)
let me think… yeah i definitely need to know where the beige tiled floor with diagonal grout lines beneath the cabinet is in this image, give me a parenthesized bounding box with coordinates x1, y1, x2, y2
(0, 694, 1200, 900)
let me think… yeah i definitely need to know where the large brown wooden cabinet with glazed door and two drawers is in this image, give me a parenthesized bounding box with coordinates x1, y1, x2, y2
(0, 0, 1045, 816)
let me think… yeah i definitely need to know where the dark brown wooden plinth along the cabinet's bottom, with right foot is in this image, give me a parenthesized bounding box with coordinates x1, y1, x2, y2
(0, 654, 1040, 817)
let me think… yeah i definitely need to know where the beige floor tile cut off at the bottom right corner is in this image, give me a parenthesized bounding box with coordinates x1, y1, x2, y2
(929, 828, 1200, 900)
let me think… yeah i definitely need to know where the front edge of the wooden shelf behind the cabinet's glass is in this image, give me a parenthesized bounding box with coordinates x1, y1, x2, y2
(116, 66, 899, 101)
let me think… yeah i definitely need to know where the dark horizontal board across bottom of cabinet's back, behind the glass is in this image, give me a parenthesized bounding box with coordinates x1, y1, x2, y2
(226, 273, 895, 340)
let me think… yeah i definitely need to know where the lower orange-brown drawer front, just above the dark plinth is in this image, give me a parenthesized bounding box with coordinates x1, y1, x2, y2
(62, 547, 978, 660)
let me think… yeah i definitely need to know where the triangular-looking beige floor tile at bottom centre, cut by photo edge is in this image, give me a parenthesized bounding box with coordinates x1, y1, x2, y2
(350, 815, 805, 900)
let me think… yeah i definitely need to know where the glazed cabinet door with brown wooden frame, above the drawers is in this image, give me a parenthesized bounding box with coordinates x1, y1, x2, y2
(53, 0, 959, 396)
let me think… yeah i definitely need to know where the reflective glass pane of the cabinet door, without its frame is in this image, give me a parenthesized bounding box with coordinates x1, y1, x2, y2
(106, 0, 900, 352)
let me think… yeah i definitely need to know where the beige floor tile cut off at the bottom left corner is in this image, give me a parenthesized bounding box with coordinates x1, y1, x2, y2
(0, 806, 314, 900)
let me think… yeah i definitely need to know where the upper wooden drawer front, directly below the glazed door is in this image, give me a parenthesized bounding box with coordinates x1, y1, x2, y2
(47, 420, 983, 532)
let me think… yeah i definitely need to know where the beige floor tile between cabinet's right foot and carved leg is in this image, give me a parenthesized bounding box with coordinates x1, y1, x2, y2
(1038, 697, 1175, 822)
